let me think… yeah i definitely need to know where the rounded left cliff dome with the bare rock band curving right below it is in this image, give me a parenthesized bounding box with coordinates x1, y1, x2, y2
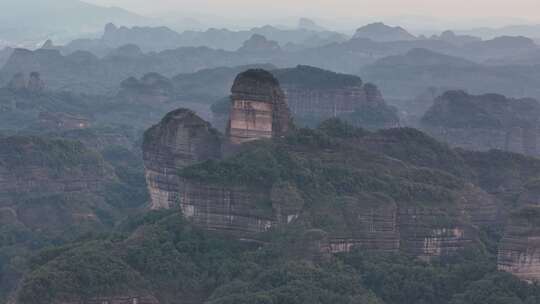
(143, 109, 287, 234)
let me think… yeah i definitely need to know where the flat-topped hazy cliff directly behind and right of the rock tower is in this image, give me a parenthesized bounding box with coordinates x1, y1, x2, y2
(273, 66, 399, 128)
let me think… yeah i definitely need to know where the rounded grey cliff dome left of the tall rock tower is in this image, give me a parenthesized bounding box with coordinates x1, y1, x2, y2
(143, 109, 221, 209)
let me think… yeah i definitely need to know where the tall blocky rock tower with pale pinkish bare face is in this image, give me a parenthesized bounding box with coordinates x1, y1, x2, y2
(227, 69, 291, 145)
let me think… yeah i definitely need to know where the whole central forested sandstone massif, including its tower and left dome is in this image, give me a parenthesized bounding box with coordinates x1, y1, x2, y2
(144, 74, 501, 260)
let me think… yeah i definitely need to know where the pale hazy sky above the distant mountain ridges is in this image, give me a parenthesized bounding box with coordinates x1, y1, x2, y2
(84, 0, 540, 21)
